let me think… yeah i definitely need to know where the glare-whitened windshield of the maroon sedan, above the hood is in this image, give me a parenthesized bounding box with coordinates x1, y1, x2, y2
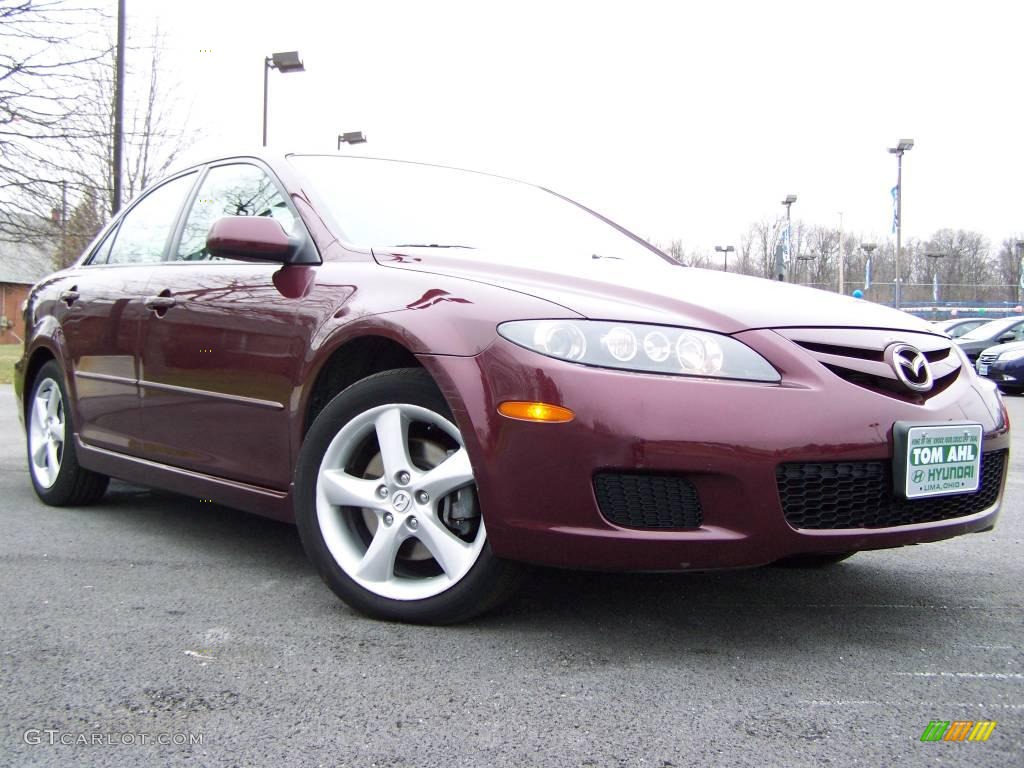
(290, 155, 665, 263)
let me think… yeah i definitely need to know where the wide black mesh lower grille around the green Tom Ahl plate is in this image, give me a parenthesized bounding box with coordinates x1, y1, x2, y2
(775, 451, 1007, 529)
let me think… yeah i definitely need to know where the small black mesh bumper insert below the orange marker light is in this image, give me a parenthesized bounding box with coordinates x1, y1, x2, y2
(594, 472, 703, 528)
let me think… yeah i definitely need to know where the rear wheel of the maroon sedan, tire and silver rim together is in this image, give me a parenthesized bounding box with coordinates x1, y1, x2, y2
(25, 360, 111, 507)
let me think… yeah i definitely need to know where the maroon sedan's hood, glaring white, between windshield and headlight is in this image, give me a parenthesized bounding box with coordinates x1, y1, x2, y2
(374, 248, 943, 336)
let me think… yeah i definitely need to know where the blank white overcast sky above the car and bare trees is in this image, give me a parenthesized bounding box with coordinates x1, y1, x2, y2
(128, 0, 1024, 259)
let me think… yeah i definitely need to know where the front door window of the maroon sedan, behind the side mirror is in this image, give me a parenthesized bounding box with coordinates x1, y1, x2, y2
(174, 164, 298, 261)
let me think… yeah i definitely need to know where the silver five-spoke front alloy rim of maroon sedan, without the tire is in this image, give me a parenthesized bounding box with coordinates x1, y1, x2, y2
(315, 403, 486, 600)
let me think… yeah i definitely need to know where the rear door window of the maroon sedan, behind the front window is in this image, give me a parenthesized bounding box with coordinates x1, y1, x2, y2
(105, 173, 196, 264)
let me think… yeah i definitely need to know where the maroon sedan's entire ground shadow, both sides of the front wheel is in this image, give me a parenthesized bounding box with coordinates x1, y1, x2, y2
(77, 482, 971, 654)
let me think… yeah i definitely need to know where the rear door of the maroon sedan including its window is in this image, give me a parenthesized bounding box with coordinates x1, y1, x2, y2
(58, 172, 198, 453)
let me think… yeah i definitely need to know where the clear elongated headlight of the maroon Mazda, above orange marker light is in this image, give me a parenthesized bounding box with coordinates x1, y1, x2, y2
(498, 321, 781, 383)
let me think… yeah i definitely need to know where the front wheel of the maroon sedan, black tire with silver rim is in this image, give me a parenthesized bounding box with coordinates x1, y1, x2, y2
(295, 369, 522, 625)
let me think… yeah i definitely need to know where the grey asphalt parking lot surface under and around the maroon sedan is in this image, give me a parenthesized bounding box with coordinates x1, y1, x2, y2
(0, 386, 1024, 768)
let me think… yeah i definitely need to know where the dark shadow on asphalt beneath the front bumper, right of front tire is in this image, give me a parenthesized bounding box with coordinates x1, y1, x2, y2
(478, 561, 984, 663)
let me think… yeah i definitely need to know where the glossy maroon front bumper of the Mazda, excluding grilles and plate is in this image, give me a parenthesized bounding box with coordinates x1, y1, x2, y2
(422, 331, 1010, 570)
